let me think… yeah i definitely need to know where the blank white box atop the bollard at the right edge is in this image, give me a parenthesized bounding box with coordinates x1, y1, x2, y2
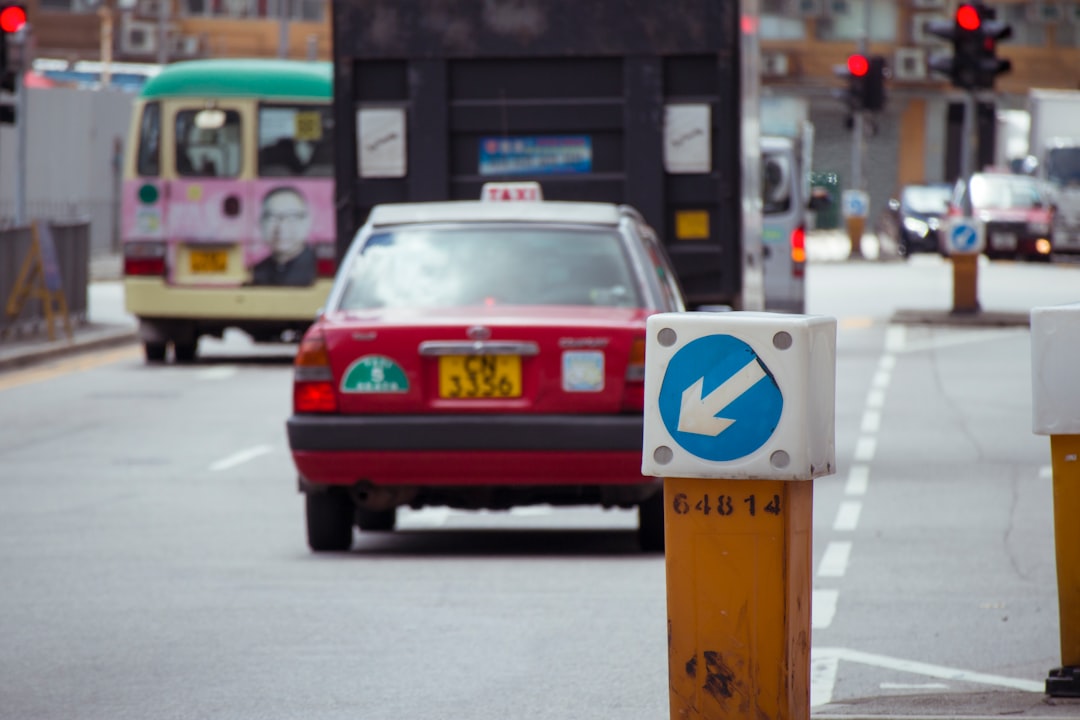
(1032, 302, 1080, 435)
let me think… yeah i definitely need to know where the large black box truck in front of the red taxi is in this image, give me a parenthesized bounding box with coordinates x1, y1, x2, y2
(332, 0, 761, 310)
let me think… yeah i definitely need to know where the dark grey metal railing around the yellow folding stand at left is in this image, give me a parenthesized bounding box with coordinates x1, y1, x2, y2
(0, 222, 91, 344)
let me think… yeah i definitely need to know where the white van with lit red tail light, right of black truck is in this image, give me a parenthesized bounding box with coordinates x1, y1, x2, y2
(761, 136, 810, 313)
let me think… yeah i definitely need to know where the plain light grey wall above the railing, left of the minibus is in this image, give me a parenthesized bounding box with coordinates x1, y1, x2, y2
(0, 87, 135, 259)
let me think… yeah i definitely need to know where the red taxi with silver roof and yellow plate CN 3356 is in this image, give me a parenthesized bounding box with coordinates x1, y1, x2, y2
(287, 191, 684, 552)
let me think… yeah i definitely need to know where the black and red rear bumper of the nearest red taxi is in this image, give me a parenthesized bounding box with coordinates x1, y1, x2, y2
(286, 415, 653, 490)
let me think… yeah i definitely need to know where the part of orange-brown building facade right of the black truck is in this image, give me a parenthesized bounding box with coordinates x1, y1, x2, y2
(759, 0, 1080, 227)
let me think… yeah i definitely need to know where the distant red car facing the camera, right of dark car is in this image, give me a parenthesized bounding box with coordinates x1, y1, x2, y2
(949, 173, 1053, 261)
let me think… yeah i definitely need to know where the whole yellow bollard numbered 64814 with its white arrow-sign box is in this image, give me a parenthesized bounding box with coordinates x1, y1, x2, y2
(642, 312, 836, 720)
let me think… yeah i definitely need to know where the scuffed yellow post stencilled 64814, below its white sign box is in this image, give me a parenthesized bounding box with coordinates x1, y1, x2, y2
(664, 477, 813, 720)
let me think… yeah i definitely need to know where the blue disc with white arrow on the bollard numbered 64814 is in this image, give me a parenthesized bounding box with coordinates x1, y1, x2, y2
(659, 335, 784, 462)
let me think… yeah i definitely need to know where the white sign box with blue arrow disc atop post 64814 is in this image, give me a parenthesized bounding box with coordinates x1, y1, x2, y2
(642, 312, 836, 480)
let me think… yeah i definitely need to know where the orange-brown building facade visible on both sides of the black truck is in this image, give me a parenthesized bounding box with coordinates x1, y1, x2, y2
(14, 0, 1080, 231)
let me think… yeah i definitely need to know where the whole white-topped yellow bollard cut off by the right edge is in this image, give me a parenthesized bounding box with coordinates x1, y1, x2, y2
(1031, 303, 1080, 697)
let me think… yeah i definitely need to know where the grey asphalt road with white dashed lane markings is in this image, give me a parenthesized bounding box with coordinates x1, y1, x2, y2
(0, 250, 1080, 720)
